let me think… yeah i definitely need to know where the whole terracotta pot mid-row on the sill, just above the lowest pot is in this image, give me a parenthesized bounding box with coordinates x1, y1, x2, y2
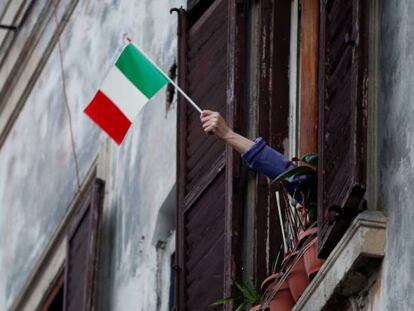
(287, 252, 309, 302)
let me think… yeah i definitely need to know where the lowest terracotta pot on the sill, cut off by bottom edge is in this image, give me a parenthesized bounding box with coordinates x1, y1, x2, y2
(262, 273, 295, 311)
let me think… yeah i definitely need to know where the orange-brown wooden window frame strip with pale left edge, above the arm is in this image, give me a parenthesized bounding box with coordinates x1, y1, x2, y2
(289, 0, 319, 157)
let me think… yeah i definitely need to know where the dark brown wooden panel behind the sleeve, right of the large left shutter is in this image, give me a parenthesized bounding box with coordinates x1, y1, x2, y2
(254, 0, 291, 286)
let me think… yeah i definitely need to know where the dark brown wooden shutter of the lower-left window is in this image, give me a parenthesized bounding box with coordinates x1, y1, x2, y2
(64, 179, 104, 311)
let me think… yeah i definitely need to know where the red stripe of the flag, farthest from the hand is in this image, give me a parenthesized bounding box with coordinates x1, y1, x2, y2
(84, 91, 131, 145)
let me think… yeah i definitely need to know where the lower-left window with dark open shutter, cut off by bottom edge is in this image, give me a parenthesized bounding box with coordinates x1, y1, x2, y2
(39, 179, 104, 311)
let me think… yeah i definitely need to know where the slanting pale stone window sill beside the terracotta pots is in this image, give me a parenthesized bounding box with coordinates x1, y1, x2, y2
(293, 211, 387, 311)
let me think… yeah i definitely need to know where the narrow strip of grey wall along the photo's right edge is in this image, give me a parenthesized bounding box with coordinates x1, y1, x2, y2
(378, 0, 414, 311)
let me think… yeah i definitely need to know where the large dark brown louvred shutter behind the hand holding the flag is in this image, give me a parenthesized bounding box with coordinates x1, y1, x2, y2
(177, 0, 242, 311)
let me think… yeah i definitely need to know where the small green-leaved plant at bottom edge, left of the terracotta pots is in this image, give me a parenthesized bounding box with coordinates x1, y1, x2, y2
(210, 281, 261, 311)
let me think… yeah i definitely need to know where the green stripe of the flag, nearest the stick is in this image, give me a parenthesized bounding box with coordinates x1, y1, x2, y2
(115, 44, 168, 99)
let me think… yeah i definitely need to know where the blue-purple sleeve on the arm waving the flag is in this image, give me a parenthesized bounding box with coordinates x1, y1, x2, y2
(242, 137, 300, 200)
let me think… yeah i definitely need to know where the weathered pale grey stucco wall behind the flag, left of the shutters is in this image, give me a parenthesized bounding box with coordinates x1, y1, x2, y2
(0, 0, 185, 310)
